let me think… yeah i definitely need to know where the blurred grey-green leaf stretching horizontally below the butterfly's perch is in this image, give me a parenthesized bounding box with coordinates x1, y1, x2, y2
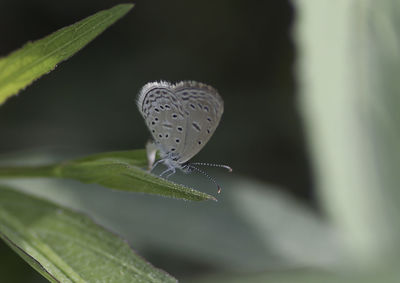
(2, 174, 343, 277)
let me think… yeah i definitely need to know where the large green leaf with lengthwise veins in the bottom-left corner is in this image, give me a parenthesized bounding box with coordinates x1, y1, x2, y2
(0, 186, 176, 282)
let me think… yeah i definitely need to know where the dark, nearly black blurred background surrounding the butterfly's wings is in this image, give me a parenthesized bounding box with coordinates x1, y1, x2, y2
(0, 0, 313, 280)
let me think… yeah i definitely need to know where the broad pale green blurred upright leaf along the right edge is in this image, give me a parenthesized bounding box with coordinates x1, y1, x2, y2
(294, 0, 400, 264)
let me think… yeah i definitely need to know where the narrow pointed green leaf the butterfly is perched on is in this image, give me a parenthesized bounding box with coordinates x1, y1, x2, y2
(0, 150, 216, 201)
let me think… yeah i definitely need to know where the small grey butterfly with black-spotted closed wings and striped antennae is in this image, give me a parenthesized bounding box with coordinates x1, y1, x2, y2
(137, 81, 232, 192)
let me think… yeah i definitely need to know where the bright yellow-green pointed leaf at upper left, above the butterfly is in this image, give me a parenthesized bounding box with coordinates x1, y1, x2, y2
(0, 4, 133, 105)
